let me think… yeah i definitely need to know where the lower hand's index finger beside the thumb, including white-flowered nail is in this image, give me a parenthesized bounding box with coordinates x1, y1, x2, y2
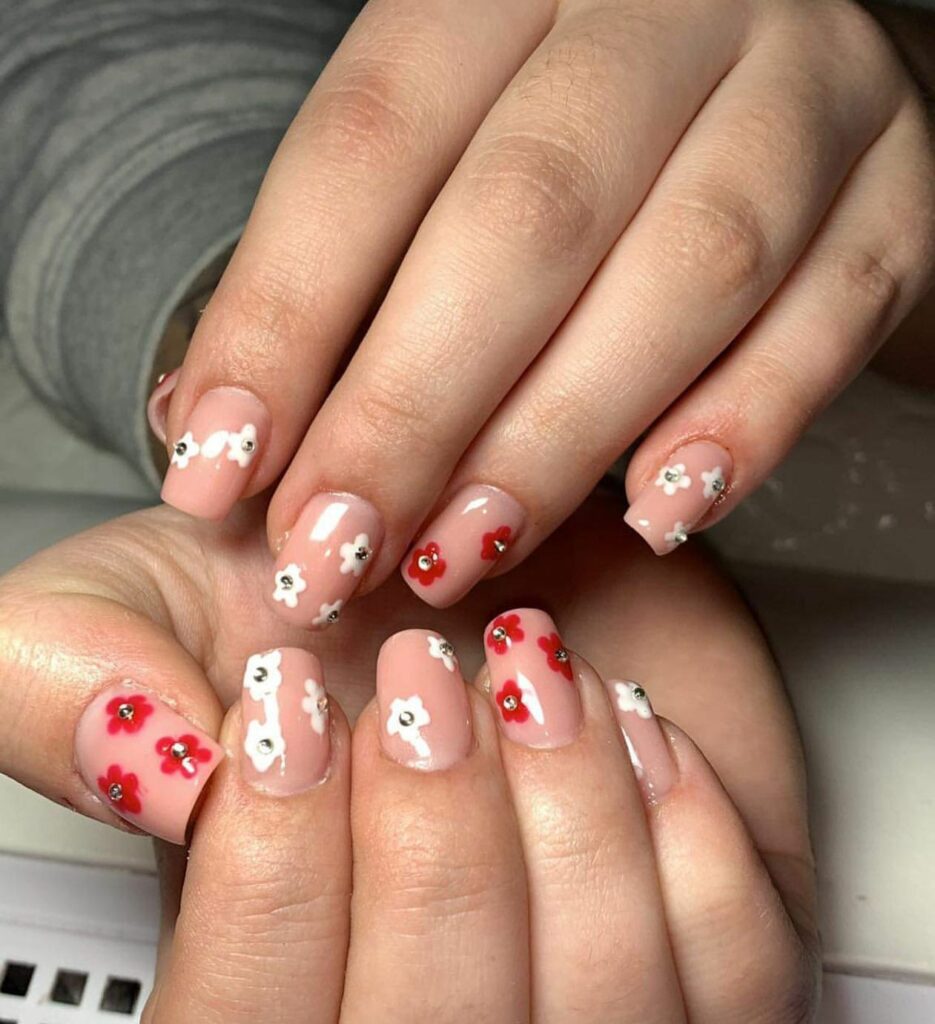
(146, 648, 351, 1024)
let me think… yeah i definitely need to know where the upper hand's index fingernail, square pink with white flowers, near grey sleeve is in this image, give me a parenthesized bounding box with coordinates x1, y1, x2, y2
(162, 387, 269, 519)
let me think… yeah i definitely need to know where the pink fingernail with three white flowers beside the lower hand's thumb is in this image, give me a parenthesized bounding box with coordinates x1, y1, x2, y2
(241, 647, 331, 797)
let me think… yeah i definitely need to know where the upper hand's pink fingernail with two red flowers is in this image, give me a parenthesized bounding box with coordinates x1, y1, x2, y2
(401, 483, 525, 608)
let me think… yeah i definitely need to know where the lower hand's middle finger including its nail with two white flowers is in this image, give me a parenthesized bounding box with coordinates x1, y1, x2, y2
(341, 630, 528, 1024)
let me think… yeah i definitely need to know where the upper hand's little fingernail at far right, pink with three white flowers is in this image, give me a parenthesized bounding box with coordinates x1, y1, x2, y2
(624, 441, 733, 555)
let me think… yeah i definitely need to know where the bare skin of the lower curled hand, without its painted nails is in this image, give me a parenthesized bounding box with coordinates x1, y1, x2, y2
(0, 497, 817, 1024)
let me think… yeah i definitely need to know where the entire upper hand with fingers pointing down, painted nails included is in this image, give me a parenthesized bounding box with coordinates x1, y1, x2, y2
(156, 0, 935, 626)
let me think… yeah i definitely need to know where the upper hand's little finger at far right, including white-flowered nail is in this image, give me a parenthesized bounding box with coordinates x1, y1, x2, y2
(627, 95, 935, 553)
